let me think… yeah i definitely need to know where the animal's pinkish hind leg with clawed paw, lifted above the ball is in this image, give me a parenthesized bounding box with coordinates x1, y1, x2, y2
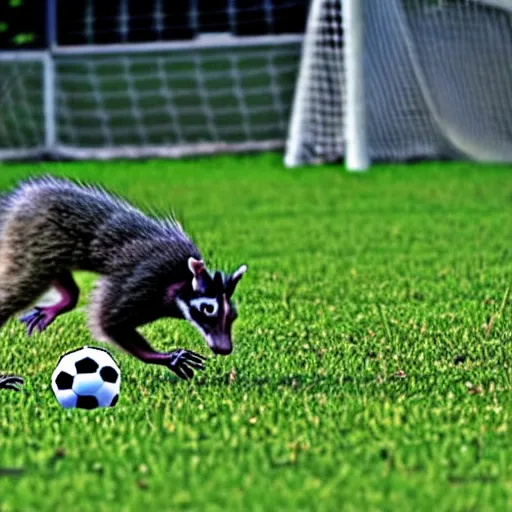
(21, 271, 80, 336)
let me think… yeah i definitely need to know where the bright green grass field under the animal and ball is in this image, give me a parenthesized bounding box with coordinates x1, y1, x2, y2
(0, 155, 512, 512)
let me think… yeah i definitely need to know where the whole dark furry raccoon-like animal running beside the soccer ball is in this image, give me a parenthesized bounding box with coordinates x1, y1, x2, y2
(0, 176, 247, 389)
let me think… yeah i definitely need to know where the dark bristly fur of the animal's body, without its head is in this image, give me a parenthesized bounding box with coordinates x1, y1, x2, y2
(0, 177, 248, 388)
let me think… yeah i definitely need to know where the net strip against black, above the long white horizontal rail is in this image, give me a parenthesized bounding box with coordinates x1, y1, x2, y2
(57, 0, 309, 45)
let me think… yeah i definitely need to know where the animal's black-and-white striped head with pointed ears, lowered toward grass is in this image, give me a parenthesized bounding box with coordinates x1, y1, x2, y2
(175, 258, 247, 355)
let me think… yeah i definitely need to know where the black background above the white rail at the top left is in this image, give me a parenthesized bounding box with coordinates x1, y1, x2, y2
(0, 0, 310, 50)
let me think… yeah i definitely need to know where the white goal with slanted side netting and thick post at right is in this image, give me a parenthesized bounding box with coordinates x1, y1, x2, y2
(285, 0, 512, 170)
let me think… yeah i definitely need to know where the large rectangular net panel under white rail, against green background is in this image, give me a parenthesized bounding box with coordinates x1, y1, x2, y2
(56, 43, 299, 158)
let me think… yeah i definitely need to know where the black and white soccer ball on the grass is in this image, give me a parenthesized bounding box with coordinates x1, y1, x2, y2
(52, 347, 121, 409)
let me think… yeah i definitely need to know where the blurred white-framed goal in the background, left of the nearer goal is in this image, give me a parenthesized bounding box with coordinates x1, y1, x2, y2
(0, 0, 308, 159)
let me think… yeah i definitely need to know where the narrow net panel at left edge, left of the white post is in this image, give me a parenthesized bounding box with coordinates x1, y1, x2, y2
(0, 53, 45, 158)
